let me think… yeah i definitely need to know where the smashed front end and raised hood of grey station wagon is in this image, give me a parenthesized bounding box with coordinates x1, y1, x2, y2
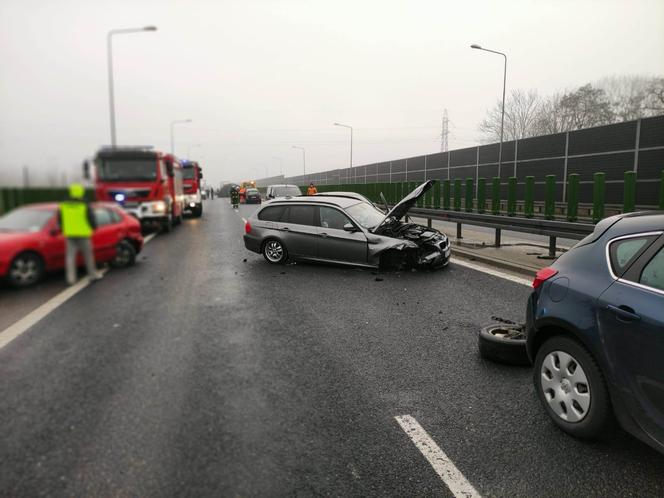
(368, 180, 450, 270)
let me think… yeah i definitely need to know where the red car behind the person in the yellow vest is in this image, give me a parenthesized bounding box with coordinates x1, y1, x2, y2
(0, 202, 143, 287)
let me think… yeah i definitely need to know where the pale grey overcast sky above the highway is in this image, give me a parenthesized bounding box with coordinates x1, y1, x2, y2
(0, 0, 664, 185)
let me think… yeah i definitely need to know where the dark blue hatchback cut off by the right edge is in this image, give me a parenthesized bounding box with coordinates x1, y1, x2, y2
(526, 212, 664, 453)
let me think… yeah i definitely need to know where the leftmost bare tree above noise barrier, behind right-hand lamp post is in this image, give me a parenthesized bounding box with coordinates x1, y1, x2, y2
(480, 90, 541, 143)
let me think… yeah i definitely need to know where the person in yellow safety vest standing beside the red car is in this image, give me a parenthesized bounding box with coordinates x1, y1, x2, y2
(58, 183, 101, 285)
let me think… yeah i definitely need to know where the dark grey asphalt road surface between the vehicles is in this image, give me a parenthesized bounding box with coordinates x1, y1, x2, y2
(0, 199, 664, 497)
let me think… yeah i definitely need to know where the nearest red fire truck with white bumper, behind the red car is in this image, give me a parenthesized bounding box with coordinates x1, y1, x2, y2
(85, 147, 184, 232)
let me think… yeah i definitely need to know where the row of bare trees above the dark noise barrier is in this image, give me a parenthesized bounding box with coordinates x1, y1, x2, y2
(479, 76, 664, 143)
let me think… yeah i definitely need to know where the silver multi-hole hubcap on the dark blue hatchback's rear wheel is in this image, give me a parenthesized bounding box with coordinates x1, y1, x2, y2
(540, 351, 591, 423)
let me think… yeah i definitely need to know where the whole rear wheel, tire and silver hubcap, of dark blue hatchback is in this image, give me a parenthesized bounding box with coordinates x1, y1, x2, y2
(533, 335, 614, 439)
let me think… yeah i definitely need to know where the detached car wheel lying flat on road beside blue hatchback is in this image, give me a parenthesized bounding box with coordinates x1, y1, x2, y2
(477, 323, 530, 366)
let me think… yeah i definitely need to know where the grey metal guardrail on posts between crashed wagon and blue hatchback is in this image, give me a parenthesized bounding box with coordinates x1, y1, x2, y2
(408, 208, 595, 258)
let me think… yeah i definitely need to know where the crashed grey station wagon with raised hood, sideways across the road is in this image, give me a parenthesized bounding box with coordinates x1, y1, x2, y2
(244, 181, 450, 269)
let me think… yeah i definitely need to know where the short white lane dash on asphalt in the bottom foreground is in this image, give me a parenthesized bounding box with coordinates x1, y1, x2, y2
(394, 415, 480, 498)
